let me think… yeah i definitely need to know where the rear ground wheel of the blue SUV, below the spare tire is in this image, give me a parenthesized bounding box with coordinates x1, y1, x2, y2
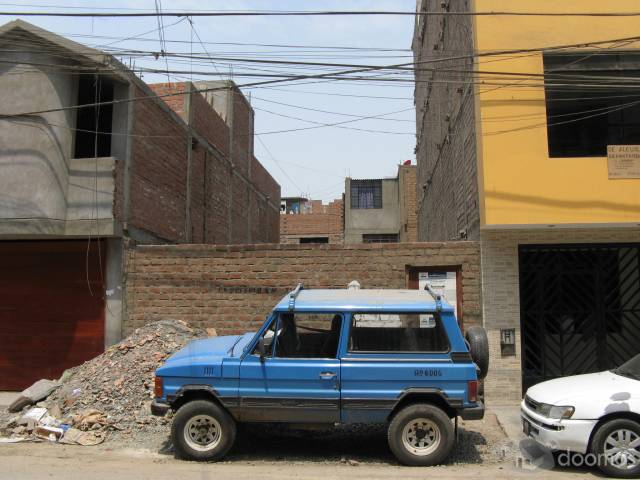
(387, 403, 455, 467)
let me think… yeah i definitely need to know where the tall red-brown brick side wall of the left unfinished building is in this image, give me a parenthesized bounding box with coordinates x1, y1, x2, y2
(120, 83, 280, 244)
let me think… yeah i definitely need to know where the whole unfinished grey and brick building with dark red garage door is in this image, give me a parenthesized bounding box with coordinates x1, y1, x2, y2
(0, 21, 280, 390)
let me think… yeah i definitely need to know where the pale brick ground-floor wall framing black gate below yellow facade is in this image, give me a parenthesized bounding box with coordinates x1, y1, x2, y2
(481, 228, 640, 404)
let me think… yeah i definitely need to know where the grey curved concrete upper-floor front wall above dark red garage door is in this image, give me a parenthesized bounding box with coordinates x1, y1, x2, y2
(0, 36, 119, 238)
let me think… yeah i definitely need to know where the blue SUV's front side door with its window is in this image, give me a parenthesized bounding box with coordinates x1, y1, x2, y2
(239, 312, 342, 423)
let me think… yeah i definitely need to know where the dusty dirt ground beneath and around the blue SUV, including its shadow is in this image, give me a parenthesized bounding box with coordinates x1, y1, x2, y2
(0, 415, 597, 480)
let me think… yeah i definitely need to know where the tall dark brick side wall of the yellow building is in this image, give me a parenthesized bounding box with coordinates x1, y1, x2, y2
(412, 0, 480, 241)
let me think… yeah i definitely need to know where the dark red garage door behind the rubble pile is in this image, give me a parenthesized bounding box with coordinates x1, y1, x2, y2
(0, 240, 105, 390)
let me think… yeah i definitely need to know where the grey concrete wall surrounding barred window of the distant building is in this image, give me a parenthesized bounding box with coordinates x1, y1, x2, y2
(344, 178, 400, 243)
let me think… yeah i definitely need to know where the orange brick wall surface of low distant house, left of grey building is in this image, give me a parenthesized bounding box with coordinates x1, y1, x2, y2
(280, 199, 344, 243)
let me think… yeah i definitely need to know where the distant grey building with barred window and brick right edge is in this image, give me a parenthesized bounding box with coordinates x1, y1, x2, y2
(344, 165, 417, 243)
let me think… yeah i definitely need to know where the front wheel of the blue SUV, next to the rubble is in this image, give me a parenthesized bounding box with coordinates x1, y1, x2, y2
(171, 400, 236, 461)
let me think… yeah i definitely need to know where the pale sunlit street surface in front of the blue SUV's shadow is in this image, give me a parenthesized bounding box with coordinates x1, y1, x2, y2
(0, 444, 599, 480)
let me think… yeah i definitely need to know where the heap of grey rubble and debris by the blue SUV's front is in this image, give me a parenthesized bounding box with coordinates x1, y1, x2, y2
(0, 320, 205, 445)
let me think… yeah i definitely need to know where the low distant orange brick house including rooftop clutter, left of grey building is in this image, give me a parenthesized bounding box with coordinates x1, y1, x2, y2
(280, 197, 344, 243)
